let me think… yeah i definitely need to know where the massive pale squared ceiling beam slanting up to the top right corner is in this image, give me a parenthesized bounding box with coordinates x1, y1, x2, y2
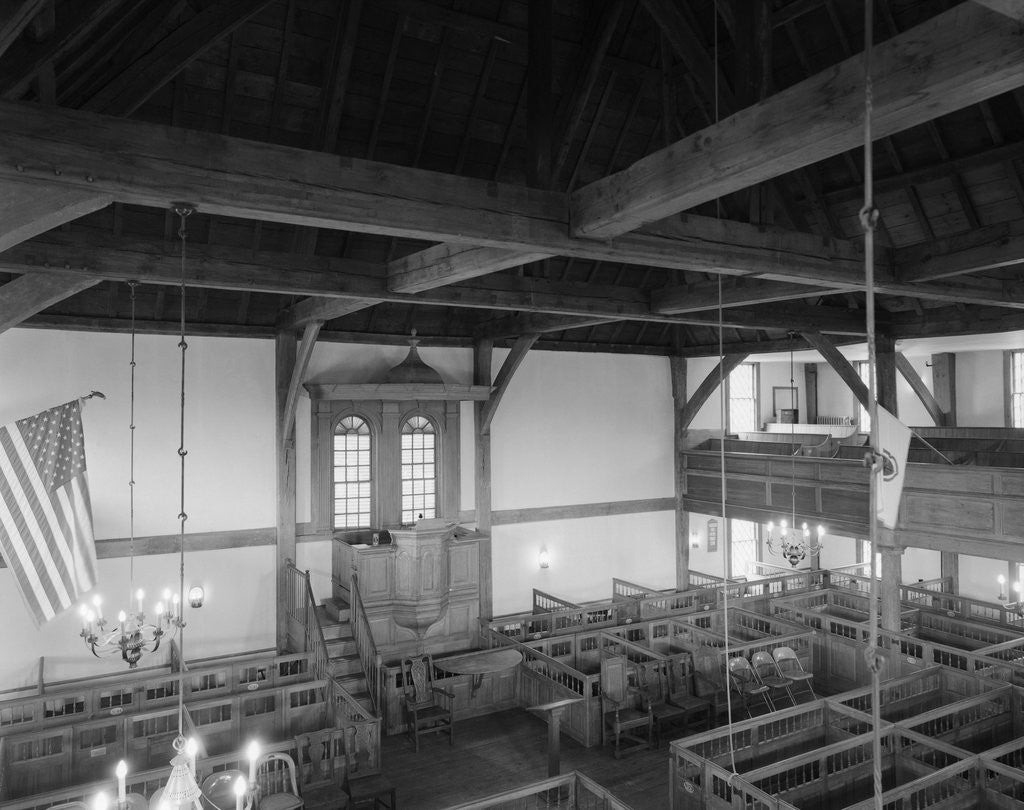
(571, 3, 1024, 239)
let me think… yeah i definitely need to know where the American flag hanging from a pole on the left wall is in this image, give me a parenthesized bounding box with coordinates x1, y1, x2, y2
(0, 399, 96, 624)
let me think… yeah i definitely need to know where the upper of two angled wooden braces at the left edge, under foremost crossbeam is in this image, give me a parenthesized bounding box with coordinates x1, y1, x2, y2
(0, 181, 111, 251)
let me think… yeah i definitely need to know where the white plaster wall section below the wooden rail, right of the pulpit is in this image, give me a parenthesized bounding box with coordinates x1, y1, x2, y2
(493, 512, 676, 615)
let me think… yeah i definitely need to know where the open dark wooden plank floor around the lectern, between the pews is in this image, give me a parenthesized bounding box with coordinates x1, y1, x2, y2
(382, 709, 669, 810)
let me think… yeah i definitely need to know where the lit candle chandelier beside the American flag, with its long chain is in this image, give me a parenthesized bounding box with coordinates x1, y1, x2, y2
(79, 281, 184, 669)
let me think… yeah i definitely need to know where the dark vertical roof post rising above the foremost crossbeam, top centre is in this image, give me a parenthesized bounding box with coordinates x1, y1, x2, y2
(528, 0, 554, 187)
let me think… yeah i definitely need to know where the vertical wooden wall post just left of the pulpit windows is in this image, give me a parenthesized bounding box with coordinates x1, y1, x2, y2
(274, 332, 298, 652)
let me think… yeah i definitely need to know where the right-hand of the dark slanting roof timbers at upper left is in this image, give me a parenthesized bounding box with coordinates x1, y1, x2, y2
(82, 0, 272, 116)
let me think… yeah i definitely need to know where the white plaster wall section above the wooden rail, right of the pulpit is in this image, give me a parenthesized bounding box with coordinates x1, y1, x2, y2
(490, 351, 673, 510)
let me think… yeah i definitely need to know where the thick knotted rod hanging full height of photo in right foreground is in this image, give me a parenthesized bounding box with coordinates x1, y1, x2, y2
(860, 0, 882, 810)
